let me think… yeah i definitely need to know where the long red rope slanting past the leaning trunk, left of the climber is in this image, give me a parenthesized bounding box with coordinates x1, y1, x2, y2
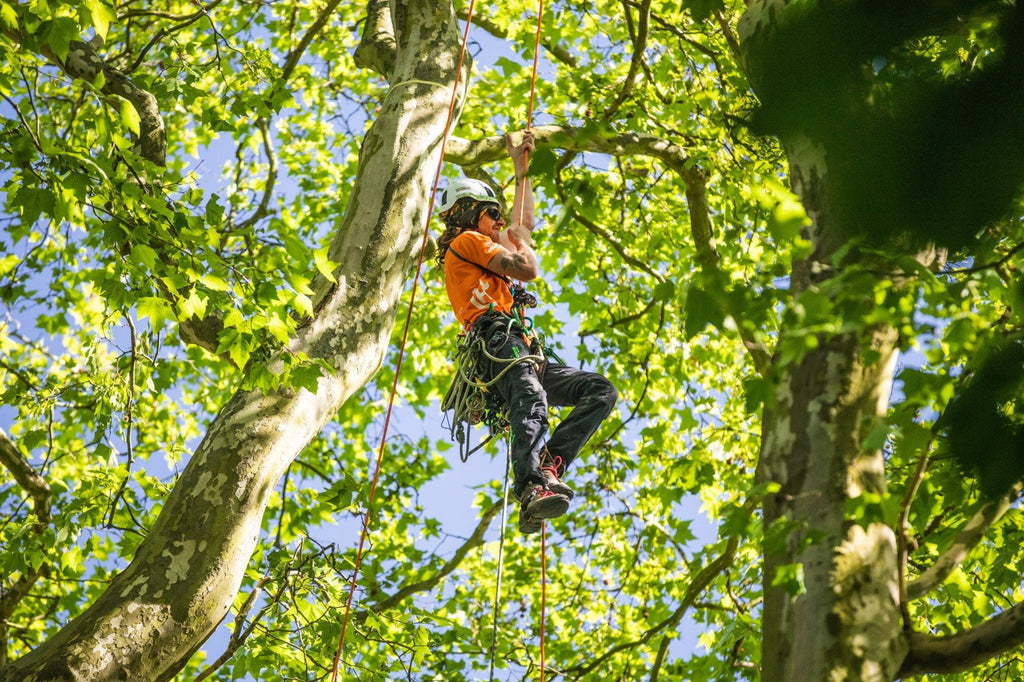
(331, 0, 475, 682)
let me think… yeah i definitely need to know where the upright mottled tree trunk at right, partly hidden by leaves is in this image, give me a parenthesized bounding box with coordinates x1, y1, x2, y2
(739, 0, 907, 682)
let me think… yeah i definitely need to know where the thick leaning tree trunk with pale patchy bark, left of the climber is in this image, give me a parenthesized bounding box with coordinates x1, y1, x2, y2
(0, 0, 465, 682)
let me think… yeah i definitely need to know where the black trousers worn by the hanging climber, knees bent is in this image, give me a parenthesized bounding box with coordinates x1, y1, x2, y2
(480, 315, 618, 497)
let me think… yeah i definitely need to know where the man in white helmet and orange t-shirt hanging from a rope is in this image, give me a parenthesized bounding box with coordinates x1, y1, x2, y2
(437, 131, 617, 534)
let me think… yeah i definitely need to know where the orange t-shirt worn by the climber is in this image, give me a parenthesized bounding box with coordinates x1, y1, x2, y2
(444, 230, 513, 327)
